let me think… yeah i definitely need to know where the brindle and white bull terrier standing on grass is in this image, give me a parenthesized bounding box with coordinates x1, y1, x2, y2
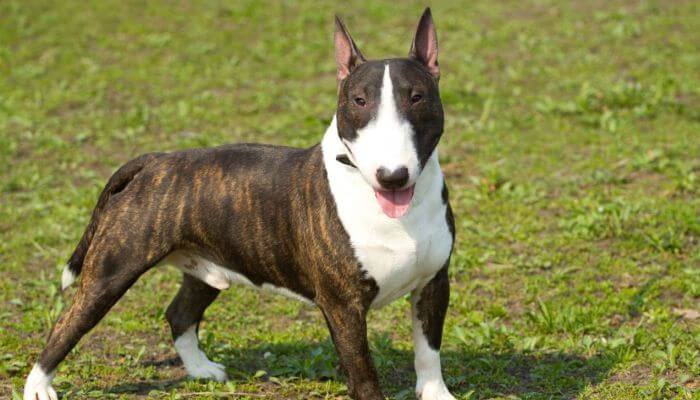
(24, 8, 455, 400)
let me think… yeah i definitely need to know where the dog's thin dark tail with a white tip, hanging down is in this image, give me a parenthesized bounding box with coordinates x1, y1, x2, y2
(61, 153, 163, 290)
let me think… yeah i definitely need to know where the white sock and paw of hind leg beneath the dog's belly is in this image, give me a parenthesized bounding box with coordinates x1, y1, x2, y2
(175, 325, 227, 382)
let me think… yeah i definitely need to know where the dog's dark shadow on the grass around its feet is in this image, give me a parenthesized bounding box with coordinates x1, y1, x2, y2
(107, 337, 618, 399)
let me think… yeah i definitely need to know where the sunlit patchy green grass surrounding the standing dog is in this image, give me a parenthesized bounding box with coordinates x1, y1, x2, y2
(0, 0, 700, 399)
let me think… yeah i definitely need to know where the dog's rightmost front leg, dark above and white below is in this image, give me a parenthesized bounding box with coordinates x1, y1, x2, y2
(411, 262, 454, 400)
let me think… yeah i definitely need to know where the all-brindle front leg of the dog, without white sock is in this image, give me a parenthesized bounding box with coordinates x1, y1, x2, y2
(319, 300, 384, 400)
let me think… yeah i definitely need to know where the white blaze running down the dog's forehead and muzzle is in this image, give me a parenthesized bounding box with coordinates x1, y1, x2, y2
(346, 64, 420, 189)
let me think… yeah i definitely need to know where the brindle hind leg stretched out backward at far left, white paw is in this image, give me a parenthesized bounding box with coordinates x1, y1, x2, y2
(24, 224, 166, 400)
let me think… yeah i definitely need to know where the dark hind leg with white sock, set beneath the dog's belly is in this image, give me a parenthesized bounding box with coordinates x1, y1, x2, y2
(165, 274, 226, 381)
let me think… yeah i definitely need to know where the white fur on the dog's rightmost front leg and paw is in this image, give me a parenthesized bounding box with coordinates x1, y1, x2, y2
(411, 289, 454, 400)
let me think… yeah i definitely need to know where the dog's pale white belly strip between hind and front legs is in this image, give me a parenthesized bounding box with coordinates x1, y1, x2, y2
(162, 250, 313, 304)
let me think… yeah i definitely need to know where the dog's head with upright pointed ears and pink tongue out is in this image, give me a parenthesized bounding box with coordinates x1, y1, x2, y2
(335, 8, 444, 218)
